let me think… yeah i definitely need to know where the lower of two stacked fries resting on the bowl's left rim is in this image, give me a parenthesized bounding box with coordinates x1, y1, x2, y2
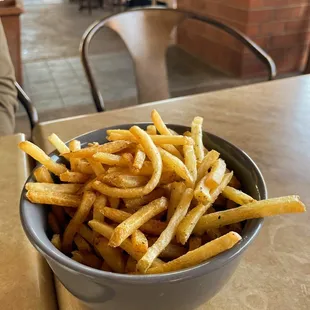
(26, 191, 81, 208)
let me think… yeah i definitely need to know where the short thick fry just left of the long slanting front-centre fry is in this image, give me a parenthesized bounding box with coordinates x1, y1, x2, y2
(109, 197, 168, 247)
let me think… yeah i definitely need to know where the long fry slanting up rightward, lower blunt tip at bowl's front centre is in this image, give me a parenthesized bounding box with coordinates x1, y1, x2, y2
(137, 188, 193, 273)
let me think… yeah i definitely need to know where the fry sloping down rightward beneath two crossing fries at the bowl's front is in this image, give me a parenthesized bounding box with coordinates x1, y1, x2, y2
(88, 220, 163, 266)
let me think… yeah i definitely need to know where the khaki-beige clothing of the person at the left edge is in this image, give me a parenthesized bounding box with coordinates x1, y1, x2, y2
(0, 20, 18, 136)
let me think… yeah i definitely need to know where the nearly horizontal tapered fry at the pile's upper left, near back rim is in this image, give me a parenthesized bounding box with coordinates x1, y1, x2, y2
(61, 141, 132, 158)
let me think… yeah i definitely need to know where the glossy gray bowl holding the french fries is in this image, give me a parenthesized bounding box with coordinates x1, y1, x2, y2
(20, 123, 267, 310)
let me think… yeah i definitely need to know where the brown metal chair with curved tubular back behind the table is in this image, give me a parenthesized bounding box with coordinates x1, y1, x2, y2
(80, 7, 276, 112)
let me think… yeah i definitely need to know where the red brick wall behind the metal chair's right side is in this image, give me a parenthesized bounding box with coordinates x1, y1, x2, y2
(178, 0, 310, 77)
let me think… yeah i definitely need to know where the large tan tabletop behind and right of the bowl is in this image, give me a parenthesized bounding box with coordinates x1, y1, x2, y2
(34, 76, 310, 310)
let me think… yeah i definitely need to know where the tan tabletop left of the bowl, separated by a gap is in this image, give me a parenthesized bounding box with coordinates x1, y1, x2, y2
(0, 134, 57, 310)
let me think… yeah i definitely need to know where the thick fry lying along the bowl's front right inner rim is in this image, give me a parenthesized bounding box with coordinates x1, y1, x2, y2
(147, 232, 242, 274)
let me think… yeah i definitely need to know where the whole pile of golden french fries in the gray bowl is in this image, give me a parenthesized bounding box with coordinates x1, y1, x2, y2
(19, 110, 305, 274)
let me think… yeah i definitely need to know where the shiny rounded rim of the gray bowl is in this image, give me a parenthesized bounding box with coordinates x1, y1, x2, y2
(20, 122, 267, 284)
